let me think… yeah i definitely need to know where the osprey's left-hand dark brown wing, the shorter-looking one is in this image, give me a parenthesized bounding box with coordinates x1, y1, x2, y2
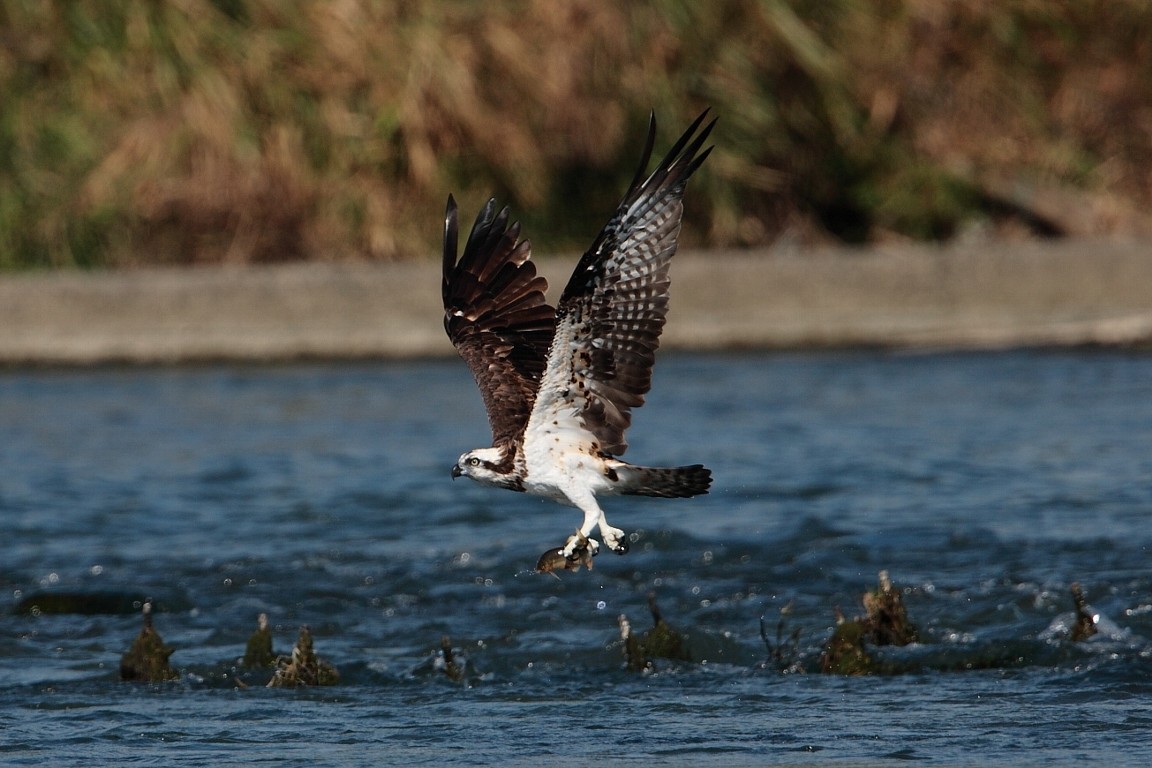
(441, 195, 555, 446)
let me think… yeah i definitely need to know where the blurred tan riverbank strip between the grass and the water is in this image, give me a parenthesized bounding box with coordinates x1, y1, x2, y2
(0, 239, 1152, 365)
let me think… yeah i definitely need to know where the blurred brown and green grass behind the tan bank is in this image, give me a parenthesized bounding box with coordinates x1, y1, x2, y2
(0, 0, 1152, 268)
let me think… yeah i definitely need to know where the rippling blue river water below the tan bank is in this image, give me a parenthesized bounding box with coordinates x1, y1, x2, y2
(0, 352, 1152, 766)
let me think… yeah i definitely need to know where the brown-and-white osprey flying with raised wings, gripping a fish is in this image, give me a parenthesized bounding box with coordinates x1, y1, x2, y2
(442, 111, 715, 571)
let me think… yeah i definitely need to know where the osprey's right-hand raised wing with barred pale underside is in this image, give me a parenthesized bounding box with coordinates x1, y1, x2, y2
(533, 111, 715, 456)
